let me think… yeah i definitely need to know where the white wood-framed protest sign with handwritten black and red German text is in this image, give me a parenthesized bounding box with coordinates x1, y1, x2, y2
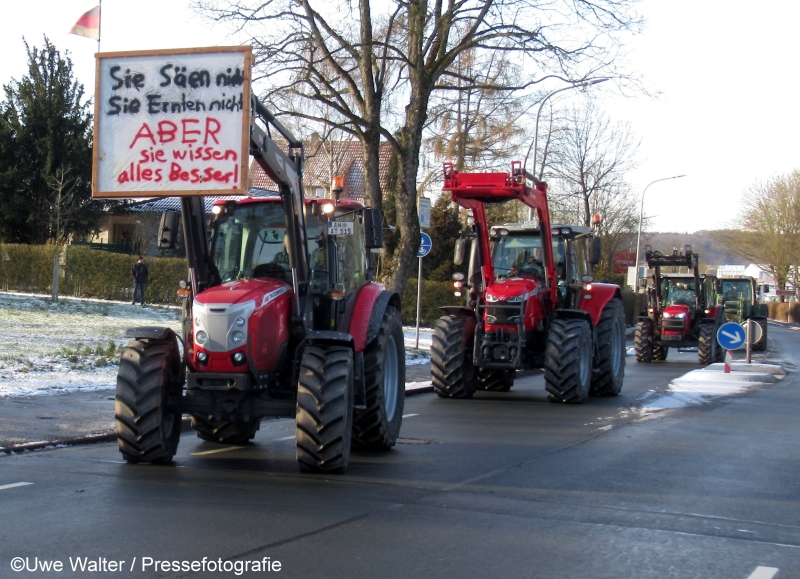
(94, 47, 250, 197)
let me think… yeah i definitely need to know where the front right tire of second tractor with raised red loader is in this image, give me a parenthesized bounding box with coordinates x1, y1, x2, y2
(544, 318, 592, 404)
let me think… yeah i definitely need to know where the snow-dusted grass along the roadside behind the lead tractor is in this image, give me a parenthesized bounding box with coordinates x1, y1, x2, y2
(0, 292, 433, 397)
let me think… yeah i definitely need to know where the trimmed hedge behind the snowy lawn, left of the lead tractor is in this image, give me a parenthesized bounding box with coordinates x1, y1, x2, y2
(0, 244, 187, 304)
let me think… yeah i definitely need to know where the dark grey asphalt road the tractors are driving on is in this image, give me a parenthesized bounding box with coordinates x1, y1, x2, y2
(0, 326, 800, 579)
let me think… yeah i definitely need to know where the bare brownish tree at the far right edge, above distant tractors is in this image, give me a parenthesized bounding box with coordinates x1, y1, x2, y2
(716, 170, 800, 301)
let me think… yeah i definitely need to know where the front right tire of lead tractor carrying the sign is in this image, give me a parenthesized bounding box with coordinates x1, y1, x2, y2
(296, 346, 353, 472)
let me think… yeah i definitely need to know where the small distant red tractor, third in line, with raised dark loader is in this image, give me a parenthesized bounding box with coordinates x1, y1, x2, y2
(635, 245, 725, 365)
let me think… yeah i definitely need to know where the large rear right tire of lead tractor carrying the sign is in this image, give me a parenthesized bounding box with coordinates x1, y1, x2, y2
(353, 307, 406, 450)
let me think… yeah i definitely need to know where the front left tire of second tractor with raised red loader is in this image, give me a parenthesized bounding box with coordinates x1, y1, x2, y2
(431, 316, 476, 398)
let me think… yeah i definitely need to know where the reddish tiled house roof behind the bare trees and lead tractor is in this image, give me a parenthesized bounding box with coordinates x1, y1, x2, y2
(250, 135, 392, 203)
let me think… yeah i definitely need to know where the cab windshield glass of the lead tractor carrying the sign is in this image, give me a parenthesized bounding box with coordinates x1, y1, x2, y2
(213, 203, 327, 282)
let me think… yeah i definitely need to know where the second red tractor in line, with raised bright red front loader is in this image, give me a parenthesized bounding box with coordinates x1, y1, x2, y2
(431, 161, 625, 403)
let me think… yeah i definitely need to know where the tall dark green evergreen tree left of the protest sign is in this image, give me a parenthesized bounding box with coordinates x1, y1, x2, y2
(0, 37, 103, 243)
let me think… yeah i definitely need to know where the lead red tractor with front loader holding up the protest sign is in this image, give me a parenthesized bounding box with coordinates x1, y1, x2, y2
(115, 98, 405, 472)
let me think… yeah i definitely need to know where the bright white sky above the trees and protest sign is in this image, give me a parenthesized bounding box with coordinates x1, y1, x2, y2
(0, 0, 800, 232)
